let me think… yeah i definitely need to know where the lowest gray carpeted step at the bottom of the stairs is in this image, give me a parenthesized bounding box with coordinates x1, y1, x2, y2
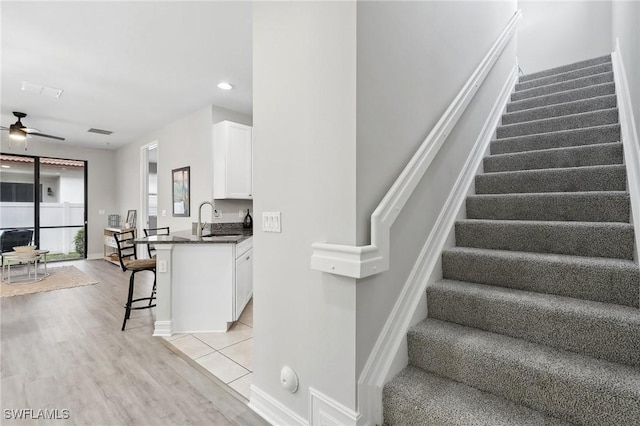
(383, 366, 568, 426)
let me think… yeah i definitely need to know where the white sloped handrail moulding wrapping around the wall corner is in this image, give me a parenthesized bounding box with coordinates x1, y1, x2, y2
(311, 10, 522, 278)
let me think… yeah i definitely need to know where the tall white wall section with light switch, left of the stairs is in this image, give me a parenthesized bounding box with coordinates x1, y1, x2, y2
(252, 1, 356, 419)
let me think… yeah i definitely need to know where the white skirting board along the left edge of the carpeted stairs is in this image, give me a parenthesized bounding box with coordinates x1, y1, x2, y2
(358, 66, 518, 424)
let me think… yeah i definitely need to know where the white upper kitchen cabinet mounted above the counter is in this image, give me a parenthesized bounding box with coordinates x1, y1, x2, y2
(213, 121, 253, 199)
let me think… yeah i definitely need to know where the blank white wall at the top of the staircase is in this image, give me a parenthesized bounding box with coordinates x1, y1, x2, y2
(518, 0, 612, 74)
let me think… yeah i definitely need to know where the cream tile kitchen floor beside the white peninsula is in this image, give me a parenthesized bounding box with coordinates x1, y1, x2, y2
(165, 299, 253, 400)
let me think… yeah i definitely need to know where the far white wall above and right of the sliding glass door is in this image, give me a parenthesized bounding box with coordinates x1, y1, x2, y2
(2, 132, 118, 257)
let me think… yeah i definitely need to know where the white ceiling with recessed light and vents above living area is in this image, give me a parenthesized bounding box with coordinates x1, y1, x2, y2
(0, 1, 252, 149)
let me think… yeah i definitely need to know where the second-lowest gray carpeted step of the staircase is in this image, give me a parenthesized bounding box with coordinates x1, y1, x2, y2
(407, 319, 640, 425)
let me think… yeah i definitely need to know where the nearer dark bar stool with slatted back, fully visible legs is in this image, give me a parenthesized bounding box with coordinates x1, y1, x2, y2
(113, 230, 156, 330)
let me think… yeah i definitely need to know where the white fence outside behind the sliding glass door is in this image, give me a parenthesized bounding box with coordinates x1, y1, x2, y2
(0, 202, 84, 254)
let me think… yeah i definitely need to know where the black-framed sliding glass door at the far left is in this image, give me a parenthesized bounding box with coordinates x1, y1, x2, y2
(0, 154, 87, 260)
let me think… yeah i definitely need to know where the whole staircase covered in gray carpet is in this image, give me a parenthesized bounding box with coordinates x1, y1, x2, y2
(383, 56, 640, 426)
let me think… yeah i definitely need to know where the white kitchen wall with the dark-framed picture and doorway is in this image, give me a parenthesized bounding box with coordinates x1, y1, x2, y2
(116, 106, 251, 232)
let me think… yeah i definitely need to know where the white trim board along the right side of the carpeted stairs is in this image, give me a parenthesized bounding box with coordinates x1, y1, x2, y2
(611, 38, 640, 263)
